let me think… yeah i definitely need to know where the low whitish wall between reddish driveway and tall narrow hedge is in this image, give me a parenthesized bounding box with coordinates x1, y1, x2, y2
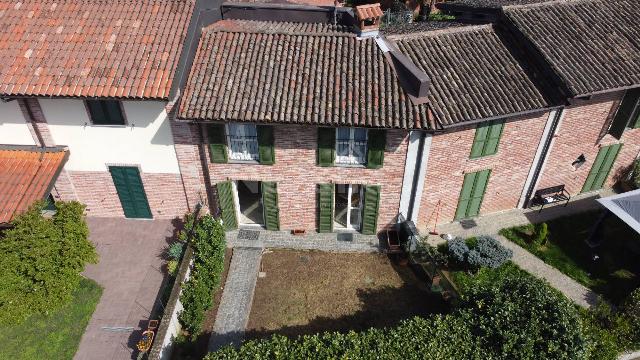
(148, 245, 193, 360)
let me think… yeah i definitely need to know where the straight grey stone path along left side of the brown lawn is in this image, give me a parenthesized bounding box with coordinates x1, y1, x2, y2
(209, 247, 263, 351)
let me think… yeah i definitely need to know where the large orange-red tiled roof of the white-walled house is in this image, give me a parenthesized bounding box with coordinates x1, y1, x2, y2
(0, 0, 195, 99)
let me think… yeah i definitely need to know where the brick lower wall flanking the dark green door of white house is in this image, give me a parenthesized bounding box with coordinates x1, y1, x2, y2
(69, 171, 187, 218)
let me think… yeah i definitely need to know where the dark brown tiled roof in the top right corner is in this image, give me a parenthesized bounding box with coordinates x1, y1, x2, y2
(504, 0, 640, 96)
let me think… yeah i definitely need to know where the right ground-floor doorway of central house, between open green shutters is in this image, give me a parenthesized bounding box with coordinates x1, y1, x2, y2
(333, 184, 364, 231)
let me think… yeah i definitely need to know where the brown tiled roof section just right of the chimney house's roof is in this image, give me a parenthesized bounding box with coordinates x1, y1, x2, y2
(389, 25, 551, 127)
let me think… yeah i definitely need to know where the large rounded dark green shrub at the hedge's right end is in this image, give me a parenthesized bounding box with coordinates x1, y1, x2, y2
(458, 274, 588, 359)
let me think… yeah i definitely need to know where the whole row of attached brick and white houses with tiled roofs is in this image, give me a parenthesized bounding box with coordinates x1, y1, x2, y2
(0, 0, 640, 234)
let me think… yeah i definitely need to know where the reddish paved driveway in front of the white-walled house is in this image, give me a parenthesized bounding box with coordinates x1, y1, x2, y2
(75, 217, 173, 360)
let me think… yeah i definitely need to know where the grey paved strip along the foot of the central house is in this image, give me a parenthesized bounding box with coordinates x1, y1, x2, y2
(227, 229, 379, 252)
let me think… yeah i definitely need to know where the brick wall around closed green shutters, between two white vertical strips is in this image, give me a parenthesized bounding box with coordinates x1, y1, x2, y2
(417, 112, 549, 227)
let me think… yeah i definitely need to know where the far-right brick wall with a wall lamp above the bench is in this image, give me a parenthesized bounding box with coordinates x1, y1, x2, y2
(537, 93, 640, 194)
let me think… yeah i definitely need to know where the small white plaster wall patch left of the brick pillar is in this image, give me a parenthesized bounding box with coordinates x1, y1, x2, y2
(0, 100, 36, 145)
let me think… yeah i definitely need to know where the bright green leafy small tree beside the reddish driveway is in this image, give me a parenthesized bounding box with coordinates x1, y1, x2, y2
(0, 201, 98, 324)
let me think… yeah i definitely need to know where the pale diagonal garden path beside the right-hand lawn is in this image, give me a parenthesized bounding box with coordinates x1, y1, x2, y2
(493, 235, 598, 308)
